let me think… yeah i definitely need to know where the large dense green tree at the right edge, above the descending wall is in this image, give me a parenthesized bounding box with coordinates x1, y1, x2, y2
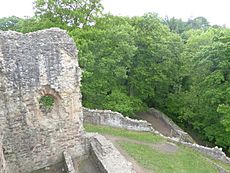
(167, 28, 230, 151)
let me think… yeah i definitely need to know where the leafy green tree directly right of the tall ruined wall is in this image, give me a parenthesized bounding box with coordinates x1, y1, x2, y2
(70, 15, 144, 116)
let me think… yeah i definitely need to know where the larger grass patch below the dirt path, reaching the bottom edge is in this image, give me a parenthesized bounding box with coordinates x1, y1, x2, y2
(119, 142, 217, 173)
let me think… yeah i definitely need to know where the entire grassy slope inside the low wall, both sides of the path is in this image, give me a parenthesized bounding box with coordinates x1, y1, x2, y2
(84, 124, 229, 173)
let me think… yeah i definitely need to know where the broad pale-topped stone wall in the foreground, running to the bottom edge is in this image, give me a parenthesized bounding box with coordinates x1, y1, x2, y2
(88, 133, 136, 173)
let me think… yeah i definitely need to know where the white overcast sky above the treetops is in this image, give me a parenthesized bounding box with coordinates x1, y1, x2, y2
(0, 0, 230, 27)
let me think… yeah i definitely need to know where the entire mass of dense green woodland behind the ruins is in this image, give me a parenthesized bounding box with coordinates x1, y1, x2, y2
(0, 0, 230, 154)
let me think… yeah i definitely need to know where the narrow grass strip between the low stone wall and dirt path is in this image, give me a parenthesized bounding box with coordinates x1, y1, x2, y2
(84, 124, 164, 143)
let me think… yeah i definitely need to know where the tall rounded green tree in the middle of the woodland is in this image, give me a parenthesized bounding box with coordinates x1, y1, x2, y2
(128, 14, 182, 108)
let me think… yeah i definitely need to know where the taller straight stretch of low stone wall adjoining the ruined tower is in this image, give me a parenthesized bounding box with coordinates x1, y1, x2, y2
(83, 108, 153, 131)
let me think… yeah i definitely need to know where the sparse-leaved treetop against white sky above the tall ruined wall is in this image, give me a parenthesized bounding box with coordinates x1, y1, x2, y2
(34, 0, 103, 27)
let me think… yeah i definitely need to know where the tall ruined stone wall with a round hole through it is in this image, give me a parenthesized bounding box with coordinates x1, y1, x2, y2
(0, 29, 85, 173)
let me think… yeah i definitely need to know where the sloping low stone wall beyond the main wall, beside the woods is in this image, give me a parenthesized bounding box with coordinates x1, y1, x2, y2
(148, 108, 195, 143)
